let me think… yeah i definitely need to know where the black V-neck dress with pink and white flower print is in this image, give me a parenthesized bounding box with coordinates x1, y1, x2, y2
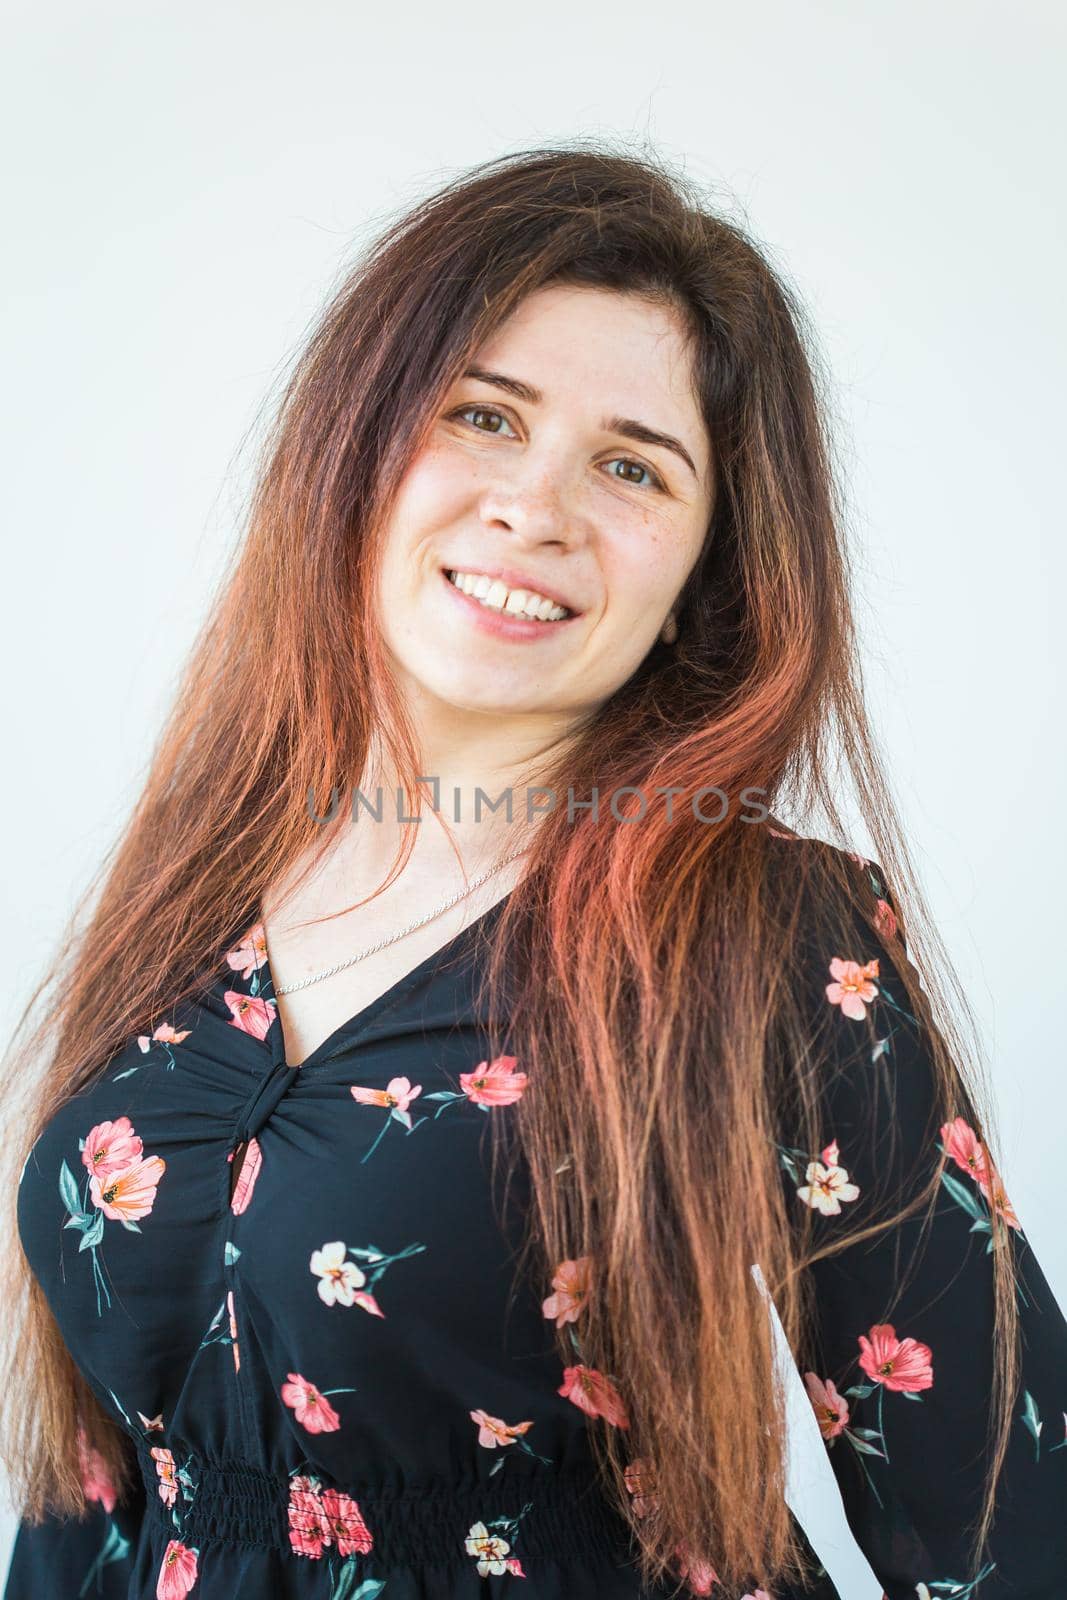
(5, 846, 1067, 1600)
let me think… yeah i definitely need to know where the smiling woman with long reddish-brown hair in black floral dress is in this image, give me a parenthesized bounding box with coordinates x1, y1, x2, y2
(3, 147, 1067, 1600)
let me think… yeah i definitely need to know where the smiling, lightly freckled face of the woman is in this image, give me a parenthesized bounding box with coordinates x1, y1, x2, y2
(379, 285, 713, 733)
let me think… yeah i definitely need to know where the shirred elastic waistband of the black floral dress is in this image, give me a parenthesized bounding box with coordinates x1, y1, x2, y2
(138, 1446, 635, 1568)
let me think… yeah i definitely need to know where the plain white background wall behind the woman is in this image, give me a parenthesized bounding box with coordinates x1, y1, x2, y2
(0, 0, 1067, 1600)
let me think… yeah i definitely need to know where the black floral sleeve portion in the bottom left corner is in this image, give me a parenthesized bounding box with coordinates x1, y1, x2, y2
(3, 1446, 144, 1600)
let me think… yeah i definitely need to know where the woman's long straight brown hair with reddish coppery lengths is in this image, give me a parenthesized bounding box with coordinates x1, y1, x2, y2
(0, 141, 1017, 1587)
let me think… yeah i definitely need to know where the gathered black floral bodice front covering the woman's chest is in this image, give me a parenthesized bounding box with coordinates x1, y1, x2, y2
(18, 973, 547, 1440)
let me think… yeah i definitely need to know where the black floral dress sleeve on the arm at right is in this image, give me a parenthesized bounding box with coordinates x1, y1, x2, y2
(779, 858, 1067, 1600)
